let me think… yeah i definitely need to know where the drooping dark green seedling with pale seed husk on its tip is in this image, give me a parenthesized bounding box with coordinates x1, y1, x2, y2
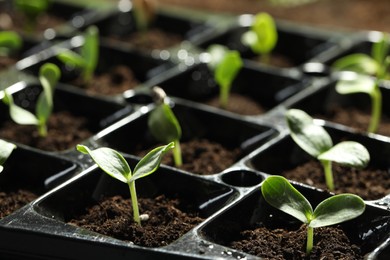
(148, 87, 183, 167)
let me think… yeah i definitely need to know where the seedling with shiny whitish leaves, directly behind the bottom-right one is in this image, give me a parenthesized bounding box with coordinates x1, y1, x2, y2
(286, 109, 370, 191)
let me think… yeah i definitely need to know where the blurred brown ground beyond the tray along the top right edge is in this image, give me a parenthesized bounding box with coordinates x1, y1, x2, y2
(159, 0, 390, 32)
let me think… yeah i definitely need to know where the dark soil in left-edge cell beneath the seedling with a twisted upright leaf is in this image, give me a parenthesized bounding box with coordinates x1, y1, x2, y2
(0, 111, 93, 151)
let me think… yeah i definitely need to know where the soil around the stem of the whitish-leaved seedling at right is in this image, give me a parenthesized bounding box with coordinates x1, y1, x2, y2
(281, 161, 390, 200)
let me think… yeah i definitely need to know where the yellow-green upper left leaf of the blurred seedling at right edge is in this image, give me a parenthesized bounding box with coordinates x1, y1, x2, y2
(332, 53, 379, 75)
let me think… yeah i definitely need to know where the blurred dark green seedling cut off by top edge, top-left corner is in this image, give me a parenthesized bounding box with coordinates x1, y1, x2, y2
(13, 0, 50, 30)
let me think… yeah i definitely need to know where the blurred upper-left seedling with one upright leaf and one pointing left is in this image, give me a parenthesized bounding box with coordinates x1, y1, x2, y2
(57, 25, 99, 83)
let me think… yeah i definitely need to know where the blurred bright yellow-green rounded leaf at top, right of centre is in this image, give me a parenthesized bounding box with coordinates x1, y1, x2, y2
(251, 13, 278, 54)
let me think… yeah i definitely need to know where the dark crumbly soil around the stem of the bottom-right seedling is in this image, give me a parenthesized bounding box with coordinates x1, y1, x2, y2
(228, 225, 363, 260)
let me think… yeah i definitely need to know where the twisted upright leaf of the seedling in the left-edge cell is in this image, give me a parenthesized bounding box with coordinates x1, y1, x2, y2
(36, 63, 61, 124)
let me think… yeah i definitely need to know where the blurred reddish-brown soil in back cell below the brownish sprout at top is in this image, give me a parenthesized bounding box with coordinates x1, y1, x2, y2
(112, 28, 184, 51)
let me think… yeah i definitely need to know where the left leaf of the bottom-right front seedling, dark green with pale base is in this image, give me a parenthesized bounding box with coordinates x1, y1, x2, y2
(261, 176, 313, 223)
